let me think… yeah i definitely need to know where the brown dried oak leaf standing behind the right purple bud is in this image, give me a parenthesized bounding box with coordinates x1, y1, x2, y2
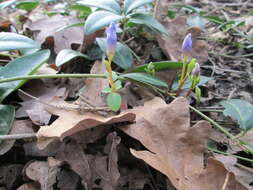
(154, 0, 208, 63)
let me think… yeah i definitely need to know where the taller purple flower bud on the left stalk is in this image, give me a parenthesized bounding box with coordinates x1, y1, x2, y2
(106, 22, 117, 59)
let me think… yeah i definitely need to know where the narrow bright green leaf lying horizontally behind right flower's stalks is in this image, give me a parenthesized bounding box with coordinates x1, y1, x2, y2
(131, 61, 183, 73)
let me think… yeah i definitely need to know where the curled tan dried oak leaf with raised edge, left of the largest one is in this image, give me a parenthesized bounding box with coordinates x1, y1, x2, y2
(37, 98, 135, 149)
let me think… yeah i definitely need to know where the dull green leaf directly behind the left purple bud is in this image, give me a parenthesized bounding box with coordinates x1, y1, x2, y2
(96, 38, 133, 70)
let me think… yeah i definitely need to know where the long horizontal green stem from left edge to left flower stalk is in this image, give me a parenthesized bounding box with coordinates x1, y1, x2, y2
(0, 74, 106, 83)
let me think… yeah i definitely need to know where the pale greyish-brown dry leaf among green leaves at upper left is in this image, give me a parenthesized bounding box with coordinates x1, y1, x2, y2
(26, 14, 83, 53)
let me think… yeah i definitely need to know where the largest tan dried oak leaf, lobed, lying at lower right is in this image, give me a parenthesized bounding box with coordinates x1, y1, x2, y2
(120, 97, 244, 190)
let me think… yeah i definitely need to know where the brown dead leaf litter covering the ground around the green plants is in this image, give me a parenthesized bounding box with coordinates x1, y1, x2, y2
(0, 0, 252, 190)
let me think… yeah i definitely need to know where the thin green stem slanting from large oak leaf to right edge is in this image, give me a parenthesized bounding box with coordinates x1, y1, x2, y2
(189, 105, 253, 154)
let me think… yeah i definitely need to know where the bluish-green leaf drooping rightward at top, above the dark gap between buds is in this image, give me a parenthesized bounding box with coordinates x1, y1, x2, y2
(129, 13, 167, 34)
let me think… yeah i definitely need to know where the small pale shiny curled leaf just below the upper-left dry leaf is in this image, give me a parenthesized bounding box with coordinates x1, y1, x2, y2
(55, 49, 89, 67)
